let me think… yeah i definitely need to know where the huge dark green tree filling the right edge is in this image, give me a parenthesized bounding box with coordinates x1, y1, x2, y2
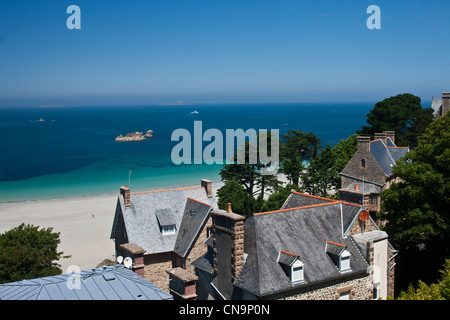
(380, 114, 450, 292)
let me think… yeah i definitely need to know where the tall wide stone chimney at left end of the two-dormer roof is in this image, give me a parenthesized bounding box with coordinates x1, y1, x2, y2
(211, 206, 244, 283)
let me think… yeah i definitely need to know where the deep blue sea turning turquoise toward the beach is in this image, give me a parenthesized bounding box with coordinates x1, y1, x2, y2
(0, 102, 374, 202)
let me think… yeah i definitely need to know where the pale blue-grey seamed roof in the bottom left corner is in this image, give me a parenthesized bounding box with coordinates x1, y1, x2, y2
(0, 265, 173, 300)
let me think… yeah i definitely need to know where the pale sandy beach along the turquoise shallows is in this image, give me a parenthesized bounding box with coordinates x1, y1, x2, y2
(0, 182, 222, 273)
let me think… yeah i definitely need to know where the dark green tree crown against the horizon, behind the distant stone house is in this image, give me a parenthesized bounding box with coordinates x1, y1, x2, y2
(358, 93, 433, 148)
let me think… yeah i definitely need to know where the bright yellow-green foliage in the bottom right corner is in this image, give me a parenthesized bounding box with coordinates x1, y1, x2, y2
(397, 259, 450, 300)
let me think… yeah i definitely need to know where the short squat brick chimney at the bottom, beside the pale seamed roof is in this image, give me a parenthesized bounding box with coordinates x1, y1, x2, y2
(166, 268, 198, 300)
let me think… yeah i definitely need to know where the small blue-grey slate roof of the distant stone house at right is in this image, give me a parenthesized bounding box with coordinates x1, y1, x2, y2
(370, 138, 409, 176)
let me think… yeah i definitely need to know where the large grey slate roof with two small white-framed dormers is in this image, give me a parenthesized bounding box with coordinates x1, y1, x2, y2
(234, 201, 369, 296)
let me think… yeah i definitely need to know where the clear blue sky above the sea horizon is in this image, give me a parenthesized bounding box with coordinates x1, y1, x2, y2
(0, 0, 450, 106)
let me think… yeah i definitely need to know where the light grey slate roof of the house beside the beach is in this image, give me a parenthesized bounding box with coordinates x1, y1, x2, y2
(111, 187, 217, 255)
